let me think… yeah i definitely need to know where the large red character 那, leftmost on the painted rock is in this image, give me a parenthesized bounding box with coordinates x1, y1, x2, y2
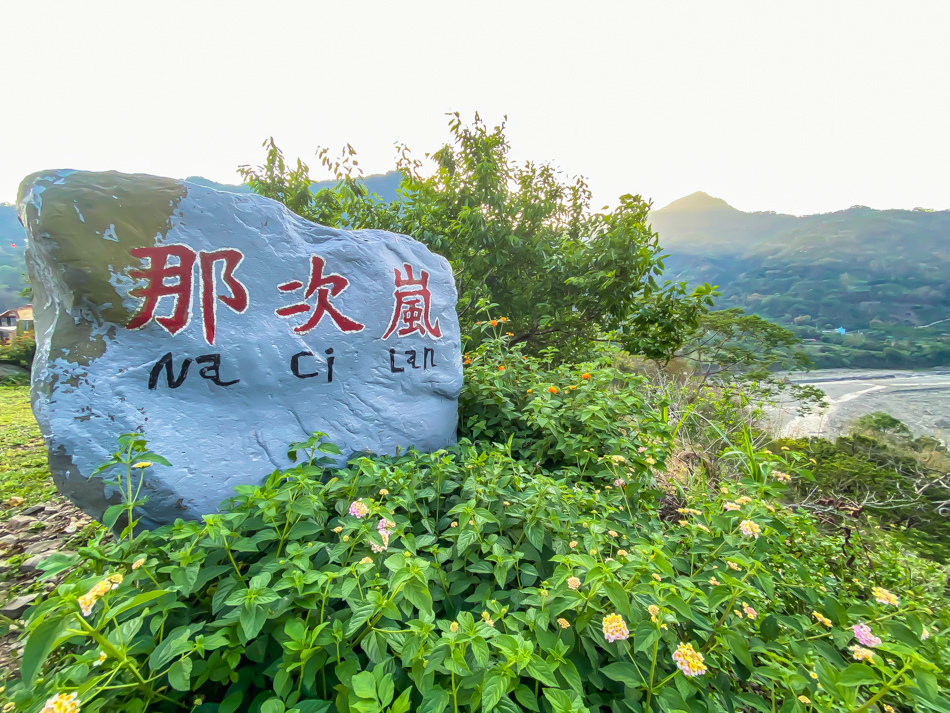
(126, 245, 248, 344)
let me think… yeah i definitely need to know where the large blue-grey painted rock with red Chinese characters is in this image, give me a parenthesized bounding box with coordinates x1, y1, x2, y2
(18, 171, 462, 526)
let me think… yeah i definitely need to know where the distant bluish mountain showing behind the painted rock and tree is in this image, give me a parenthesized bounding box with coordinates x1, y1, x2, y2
(0, 171, 400, 312)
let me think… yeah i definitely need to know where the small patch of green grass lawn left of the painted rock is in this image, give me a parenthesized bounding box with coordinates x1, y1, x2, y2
(0, 386, 56, 520)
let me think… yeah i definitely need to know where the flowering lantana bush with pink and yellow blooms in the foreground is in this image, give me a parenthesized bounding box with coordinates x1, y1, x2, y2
(4, 334, 950, 713)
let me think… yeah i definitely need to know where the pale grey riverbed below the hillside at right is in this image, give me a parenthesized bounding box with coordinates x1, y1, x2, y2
(773, 369, 950, 443)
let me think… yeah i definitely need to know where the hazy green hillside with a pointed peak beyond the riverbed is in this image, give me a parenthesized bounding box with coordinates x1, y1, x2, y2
(650, 193, 950, 368)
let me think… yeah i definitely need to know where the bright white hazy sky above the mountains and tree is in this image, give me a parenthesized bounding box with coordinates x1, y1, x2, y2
(0, 0, 950, 213)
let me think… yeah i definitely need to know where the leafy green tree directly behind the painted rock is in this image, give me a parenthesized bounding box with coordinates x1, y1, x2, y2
(239, 114, 712, 358)
